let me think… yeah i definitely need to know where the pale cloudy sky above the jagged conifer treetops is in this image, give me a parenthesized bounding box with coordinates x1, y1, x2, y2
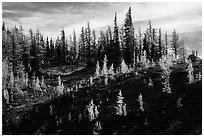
(2, 2, 202, 56)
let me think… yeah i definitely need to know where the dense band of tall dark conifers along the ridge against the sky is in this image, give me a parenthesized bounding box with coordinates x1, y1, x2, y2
(2, 7, 186, 77)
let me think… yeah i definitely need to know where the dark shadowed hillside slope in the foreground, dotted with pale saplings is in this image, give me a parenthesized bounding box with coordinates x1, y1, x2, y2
(3, 60, 202, 135)
